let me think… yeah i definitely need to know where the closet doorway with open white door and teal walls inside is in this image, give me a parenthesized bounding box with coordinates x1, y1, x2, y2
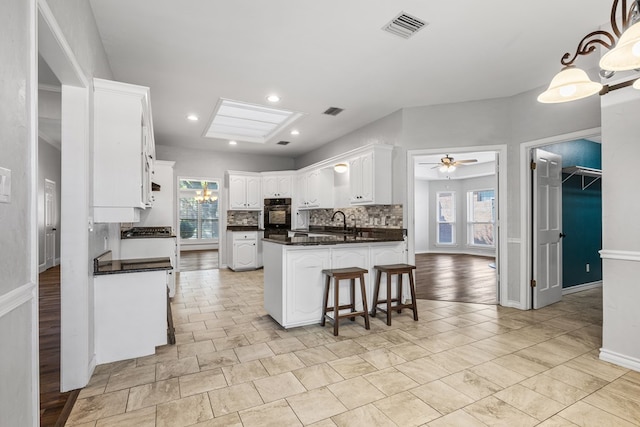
(531, 137, 602, 308)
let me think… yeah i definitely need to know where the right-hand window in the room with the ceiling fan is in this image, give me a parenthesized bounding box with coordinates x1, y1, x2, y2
(467, 190, 496, 247)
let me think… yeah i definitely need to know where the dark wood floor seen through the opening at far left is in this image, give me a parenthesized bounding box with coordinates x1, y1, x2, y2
(38, 266, 79, 426)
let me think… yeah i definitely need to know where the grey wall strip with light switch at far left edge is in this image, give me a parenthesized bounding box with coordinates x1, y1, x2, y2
(0, 0, 38, 426)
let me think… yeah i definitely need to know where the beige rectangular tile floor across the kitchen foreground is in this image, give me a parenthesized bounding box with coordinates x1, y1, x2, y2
(66, 270, 640, 427)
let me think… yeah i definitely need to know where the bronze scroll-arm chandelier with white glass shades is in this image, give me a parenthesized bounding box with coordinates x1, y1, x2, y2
(538, 0, 640, 103)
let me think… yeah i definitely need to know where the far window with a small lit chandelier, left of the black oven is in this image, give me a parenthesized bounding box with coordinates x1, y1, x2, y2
(179, 179, 220, 243)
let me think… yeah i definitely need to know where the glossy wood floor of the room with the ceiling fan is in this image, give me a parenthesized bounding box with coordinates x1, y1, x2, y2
(415, 254, 498, 304)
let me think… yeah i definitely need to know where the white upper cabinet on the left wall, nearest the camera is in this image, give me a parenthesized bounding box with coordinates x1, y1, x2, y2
(93, 79, 155, 222)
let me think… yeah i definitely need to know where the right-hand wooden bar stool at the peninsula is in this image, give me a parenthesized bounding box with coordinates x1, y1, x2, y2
(371, 264, 418, 326)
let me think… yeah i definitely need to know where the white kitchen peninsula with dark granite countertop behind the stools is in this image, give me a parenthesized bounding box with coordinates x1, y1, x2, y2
(263, 229, 407, 328)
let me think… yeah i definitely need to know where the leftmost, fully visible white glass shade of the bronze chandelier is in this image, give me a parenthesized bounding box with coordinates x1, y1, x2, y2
(538, 67, 602, 104)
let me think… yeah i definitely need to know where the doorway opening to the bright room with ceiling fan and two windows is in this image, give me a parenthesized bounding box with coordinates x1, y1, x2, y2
(407, 146, 506, 304)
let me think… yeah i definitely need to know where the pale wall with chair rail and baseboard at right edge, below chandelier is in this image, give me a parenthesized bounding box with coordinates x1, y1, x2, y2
(600, 82, 640, 371)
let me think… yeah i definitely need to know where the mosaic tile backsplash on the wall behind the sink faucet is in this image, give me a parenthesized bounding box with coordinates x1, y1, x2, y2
(309, 205, 402, 228)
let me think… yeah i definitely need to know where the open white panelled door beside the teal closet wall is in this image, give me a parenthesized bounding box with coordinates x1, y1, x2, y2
(531, 148, 564, 309)
